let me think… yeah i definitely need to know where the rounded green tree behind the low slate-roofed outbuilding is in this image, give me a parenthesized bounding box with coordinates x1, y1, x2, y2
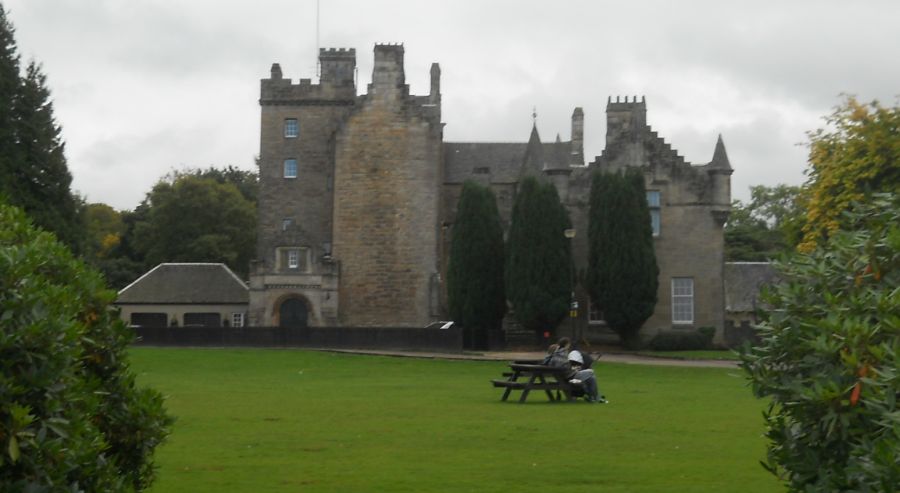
(128, 175, 256, 277)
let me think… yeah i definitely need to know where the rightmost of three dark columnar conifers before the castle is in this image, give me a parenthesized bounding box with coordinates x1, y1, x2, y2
(587, 168, 659, 347)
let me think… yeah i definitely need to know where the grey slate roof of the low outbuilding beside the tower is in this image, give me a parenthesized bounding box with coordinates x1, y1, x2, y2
(116, 263, 250, 305)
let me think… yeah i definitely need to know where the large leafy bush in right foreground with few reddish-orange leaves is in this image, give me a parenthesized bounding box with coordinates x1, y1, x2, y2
(741, 194, 900, 492)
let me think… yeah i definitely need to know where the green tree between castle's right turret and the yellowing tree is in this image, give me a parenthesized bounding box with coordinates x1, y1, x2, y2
(725, 185, 806, 262)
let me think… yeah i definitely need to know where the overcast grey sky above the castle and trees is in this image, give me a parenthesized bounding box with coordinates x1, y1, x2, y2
(0, 0, 900, 209)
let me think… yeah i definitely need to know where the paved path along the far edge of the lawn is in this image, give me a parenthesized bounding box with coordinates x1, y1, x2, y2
(319, 349, 738, 368)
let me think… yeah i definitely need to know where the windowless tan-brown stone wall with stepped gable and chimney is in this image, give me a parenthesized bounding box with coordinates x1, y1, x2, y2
(333, 45, 443, 327)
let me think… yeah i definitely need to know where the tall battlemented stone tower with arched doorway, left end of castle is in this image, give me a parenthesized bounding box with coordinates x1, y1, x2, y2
(249, 45, 443, 326)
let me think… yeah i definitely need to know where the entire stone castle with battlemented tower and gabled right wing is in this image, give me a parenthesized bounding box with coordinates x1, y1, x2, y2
(248, 45, 732, 342)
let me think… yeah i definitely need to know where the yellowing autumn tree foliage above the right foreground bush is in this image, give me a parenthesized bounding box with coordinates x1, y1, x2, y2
(800, 97, 900, 251)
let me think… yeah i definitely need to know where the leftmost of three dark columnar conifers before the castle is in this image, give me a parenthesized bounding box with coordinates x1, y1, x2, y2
(447, 181, 506, 348)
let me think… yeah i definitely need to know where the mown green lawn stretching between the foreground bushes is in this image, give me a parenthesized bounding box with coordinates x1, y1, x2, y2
(131, 348, 782, 493)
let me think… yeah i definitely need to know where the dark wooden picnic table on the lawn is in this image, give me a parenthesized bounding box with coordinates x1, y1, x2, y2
(491, 361, 582, 403)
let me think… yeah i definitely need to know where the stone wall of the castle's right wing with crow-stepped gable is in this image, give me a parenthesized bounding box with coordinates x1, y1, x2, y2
(567, 98, 731, 343)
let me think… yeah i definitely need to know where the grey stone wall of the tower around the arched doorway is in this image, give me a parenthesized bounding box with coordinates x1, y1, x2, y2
(248, 49, 357, 325)
